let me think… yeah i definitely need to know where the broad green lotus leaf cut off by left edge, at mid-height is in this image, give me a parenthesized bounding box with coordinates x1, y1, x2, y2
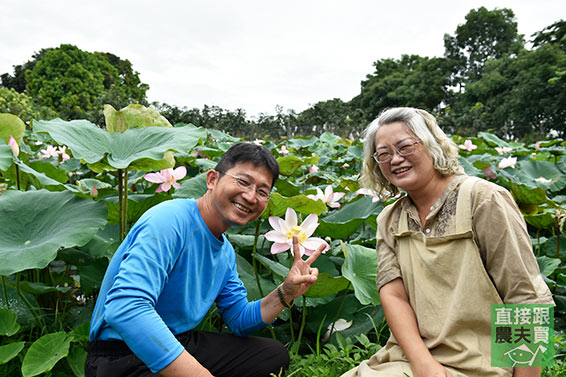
(0, 190, 107, 275)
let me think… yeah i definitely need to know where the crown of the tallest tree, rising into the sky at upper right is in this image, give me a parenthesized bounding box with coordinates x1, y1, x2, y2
(444, 7, 524, 89)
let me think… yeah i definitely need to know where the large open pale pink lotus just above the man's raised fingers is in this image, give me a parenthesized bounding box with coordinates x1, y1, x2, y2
(265, 207, 330, 256)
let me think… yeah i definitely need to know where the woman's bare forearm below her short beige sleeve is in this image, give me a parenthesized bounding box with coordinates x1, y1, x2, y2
(379, 278, 451, 377)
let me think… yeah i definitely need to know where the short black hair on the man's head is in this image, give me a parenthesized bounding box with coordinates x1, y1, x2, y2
(215, 143, 279, 187)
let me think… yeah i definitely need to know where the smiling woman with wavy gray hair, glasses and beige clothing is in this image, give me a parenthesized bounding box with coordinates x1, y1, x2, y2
(343, 107, 553, 377)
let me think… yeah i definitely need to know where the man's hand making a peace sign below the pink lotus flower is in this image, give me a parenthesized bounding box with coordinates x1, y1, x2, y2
(281, 236, 328, 303)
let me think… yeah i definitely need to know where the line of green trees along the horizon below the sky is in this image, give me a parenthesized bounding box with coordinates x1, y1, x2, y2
(0, 7, 566, 141)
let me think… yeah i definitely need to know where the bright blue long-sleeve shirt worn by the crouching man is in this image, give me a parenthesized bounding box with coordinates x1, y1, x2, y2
(90, 199, 266, 373)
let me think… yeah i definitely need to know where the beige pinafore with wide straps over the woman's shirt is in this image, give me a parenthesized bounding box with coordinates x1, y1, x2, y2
(343, 177, 512, 377)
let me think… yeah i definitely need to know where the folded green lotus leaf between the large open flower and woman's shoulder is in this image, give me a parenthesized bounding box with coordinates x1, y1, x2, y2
(316, 196, 383, 238)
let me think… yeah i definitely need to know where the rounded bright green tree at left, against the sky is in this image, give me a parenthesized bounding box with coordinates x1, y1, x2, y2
(2, 44, 149, 123)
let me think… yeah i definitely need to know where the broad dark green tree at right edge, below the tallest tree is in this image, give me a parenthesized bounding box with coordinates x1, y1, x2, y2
(443, 44, 566, 139)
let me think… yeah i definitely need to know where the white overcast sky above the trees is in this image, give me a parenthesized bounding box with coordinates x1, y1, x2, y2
(0, 0, 566, 116)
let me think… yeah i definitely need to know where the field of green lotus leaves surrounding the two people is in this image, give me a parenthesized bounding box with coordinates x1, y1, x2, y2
(0, 105, 566, 377)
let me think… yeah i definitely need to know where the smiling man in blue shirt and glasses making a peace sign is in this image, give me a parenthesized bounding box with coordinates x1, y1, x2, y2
(85, 143, 326, 377)
